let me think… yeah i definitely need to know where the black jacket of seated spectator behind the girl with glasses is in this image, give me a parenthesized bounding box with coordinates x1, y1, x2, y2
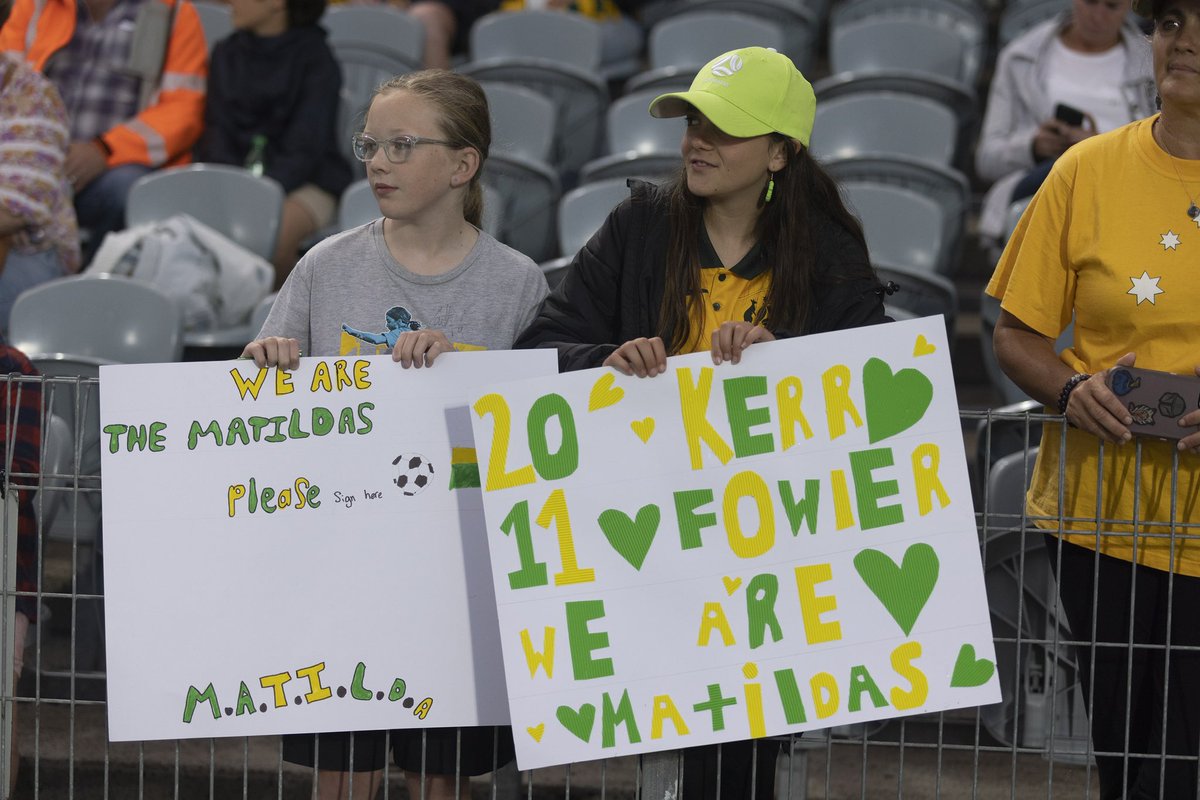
(193, 25, 350, 197)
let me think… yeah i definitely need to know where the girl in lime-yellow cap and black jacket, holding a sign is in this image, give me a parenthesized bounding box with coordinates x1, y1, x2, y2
(516, 47, 890, 800)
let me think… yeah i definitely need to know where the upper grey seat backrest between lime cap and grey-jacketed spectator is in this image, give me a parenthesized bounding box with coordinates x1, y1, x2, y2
(829, 17, 974, 85)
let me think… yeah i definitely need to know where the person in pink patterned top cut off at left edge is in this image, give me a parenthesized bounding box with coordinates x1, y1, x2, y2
(0, 0, 79, 335)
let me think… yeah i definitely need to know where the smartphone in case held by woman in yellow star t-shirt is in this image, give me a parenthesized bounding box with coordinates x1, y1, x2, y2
(1105, 367, 1200, 440)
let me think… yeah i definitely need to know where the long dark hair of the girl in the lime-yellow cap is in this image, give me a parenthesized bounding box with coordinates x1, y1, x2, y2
(658, 133, 866, 354)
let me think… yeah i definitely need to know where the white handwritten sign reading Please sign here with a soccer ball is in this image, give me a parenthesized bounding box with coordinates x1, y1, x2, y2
(101, 351, 557, 740)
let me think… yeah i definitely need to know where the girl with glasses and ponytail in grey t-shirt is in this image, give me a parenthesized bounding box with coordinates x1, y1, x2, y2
(242, 70, 547, 800)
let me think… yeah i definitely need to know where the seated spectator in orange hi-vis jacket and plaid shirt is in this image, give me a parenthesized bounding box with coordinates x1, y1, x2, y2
(0, 0, 208, 261)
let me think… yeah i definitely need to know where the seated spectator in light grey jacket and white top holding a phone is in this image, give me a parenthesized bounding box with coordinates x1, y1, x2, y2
(976, 0, 1154, 239)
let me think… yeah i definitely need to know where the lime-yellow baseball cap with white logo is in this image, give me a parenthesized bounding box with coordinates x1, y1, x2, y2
(650, 47, 817, 146)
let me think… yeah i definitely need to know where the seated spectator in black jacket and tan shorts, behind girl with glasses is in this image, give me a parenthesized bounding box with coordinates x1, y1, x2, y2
(193, 0, 350, 289)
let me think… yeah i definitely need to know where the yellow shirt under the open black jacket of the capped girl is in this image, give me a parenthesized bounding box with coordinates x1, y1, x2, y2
(683, 225, 770, 353)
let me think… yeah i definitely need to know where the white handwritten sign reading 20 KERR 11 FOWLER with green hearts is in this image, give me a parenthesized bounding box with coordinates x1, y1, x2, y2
(472, 318, 1000, 769)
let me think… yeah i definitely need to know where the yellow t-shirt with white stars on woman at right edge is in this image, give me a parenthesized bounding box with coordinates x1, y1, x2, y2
(988, 116, 1200, 576)
